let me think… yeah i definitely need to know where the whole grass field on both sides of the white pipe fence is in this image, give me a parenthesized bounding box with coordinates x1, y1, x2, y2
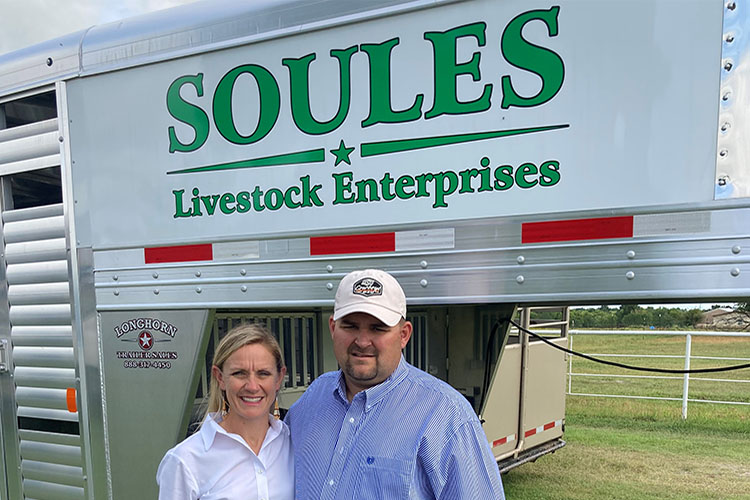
(503, 336, 750, 500)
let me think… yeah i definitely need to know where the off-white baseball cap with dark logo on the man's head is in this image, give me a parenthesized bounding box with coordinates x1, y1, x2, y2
(333, 269, 406, 326)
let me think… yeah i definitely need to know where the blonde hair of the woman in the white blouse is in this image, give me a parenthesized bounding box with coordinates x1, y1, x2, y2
(201, 323, 284, 420)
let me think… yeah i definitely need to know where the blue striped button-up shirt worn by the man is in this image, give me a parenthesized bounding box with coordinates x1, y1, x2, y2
(286, 357, 505, 500)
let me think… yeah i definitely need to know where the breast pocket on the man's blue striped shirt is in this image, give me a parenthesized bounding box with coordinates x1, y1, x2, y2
(360, 456, 412, 500)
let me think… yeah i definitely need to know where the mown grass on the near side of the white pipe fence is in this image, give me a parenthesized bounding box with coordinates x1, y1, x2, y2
(503, 396, 750, 500)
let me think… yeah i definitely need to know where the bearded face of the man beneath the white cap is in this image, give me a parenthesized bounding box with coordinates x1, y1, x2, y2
(329, 313, 412, 398)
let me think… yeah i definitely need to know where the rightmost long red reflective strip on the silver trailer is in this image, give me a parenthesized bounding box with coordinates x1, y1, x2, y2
(521, 216, 633, 243)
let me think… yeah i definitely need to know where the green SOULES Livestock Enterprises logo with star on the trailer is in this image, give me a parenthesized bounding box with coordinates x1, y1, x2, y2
(166, 6, 569, 219)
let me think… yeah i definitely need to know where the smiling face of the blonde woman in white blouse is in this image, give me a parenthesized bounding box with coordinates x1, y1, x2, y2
(211, 344, 286, 421)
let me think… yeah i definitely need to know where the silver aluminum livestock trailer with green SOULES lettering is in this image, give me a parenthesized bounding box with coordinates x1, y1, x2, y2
(0, 0, 750, 500)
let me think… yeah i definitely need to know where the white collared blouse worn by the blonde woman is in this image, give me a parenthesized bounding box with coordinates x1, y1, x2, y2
(156, 413, 294, 500)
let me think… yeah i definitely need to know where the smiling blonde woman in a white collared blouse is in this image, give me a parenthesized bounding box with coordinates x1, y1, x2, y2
(156, 324, 294, 500)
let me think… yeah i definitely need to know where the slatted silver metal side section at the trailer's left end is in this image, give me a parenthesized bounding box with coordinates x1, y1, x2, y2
(0, 99, 86, 500)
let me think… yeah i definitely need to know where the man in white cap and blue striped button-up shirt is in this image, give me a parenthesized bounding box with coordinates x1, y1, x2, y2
(286, 269, 505, 500)
